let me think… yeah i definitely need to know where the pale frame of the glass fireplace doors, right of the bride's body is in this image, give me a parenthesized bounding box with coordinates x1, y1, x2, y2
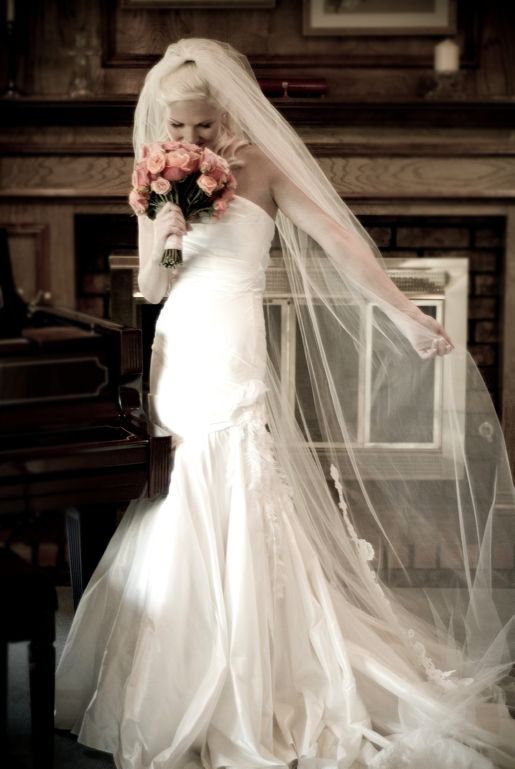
(265, 257, 468, 478)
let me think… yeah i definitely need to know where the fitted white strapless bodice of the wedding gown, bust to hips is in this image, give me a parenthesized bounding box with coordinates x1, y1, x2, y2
(150, 196, 274, 438)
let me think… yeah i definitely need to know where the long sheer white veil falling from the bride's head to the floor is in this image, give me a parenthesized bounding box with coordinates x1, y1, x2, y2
(134, 38, 515, 767)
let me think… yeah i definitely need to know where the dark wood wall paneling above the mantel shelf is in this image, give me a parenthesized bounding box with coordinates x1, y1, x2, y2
(9, 0, 515, 100)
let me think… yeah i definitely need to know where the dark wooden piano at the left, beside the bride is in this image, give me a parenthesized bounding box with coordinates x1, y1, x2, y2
(0, 230, 172, 603)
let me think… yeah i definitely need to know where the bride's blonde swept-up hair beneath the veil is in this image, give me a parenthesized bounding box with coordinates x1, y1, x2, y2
(157, 60, 249, 168)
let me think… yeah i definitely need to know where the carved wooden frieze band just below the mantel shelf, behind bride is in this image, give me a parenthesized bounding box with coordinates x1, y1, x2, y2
(0, 149, 515, 200)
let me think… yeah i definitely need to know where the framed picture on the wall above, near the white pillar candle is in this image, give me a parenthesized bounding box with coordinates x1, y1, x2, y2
(303, 0, 456, 35)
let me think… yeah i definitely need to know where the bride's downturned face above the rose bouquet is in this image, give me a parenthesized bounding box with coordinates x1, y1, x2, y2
(167, 99, 222, 149)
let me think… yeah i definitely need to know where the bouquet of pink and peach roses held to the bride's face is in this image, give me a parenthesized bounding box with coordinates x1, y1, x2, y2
(129, 141, 236, 267)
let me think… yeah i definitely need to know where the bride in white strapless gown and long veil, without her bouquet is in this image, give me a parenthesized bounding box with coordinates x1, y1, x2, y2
(56, 39, 515, 769)
